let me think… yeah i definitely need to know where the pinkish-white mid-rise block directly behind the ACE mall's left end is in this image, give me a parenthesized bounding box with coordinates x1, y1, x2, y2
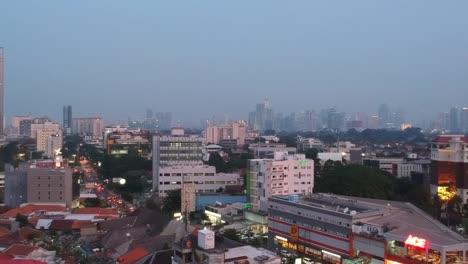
(247, 152, 314, 211)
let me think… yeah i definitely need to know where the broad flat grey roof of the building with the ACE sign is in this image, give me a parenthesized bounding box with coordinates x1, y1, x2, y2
(272, 193, 468, 248)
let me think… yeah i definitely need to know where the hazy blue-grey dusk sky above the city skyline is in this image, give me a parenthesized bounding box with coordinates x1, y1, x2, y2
(0, 0, 468, 123)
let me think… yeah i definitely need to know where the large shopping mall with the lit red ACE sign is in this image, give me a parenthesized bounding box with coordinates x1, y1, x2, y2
(268, 194, 468, 264)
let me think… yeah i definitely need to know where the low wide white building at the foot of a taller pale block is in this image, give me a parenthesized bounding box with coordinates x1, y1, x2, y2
(153, 165, 240, 196)
